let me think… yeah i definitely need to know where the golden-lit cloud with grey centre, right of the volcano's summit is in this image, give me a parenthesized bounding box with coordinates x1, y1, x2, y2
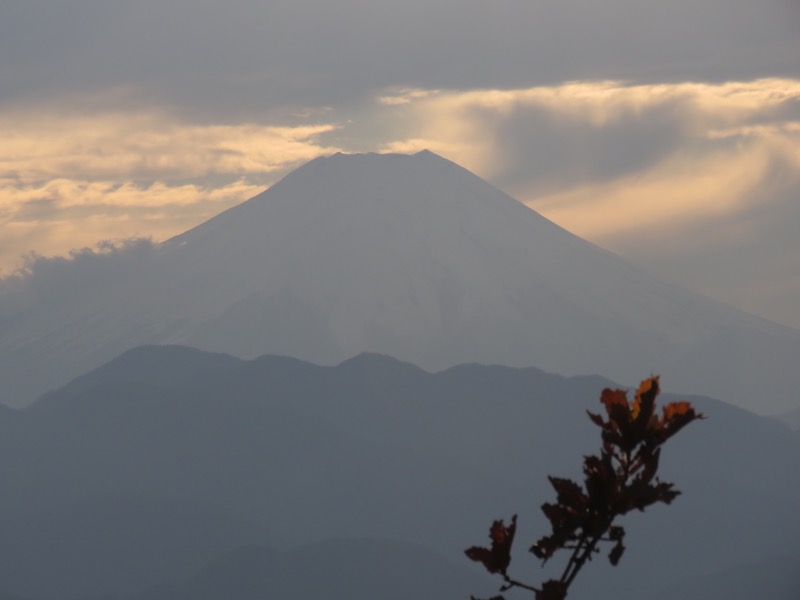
(374, 79, 800, 240)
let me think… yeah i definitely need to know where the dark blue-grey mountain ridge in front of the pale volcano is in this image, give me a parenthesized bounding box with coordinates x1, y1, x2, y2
(0, 346, 800, 600)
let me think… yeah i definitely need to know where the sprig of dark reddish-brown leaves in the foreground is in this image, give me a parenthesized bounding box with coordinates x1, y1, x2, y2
(466, 377, 703, 600)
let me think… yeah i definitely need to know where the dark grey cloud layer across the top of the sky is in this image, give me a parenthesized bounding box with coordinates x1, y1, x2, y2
(0, 0, 800, 119)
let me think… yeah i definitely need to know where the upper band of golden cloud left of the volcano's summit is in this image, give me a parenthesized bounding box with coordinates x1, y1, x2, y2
(0, 107, 337, 184)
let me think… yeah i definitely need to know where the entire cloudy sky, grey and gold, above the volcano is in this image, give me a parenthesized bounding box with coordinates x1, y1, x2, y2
(0, 0, 800, 328)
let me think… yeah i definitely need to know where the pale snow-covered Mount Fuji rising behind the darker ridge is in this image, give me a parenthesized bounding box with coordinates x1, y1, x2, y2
(0, 151, 800, 414)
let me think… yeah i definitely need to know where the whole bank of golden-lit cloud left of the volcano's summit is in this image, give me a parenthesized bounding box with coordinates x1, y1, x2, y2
(0, 107, 339, 274)
